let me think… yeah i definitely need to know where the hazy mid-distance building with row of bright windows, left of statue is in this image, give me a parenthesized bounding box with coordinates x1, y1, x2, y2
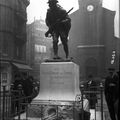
(26, 19, 52, 80)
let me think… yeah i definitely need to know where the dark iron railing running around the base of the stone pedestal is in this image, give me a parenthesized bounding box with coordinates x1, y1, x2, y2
(0, 84, 104, 120)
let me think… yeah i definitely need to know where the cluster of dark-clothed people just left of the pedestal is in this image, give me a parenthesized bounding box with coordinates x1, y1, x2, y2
(12, 74, 39, 112)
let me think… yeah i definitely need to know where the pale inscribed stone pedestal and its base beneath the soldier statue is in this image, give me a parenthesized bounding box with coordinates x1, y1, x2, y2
(28, 62, 87, 120)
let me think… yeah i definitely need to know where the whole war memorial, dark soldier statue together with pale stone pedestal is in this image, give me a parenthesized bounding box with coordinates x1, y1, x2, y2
(28, 0, 90, 120)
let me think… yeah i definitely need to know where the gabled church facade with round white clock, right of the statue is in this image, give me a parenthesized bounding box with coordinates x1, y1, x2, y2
(60, 0, 120, 80)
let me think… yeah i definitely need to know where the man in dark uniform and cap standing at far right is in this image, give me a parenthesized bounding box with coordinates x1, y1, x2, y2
(105, 68, 119, 120)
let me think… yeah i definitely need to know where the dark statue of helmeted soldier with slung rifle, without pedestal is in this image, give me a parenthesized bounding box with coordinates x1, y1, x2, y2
(45, 0, 71, 59)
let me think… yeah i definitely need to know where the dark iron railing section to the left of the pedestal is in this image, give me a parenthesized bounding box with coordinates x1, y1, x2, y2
(0, 86, 32, 120)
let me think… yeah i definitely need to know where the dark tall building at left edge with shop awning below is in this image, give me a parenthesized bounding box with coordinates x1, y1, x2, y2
(0, 0, 31, 89)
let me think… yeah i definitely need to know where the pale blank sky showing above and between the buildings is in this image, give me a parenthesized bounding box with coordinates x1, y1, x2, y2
(27, 0, 119, 37)
